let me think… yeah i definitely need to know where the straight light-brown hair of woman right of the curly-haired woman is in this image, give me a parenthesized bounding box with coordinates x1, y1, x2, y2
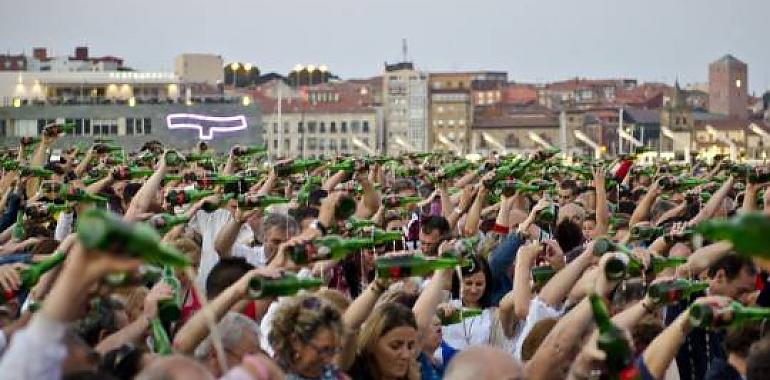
(357, 302, 420, 380)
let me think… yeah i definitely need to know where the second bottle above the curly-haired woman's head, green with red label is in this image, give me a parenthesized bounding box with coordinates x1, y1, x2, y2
(289, 235, 374, 265)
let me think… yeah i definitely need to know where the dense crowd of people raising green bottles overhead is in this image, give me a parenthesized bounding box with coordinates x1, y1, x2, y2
(0, 124, 770, 380)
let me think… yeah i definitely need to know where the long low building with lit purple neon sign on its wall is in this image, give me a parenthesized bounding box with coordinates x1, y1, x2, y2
(0, 71, 262, 150)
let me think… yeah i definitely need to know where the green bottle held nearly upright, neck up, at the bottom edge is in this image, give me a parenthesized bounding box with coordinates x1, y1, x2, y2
(589, 294, 636, 380)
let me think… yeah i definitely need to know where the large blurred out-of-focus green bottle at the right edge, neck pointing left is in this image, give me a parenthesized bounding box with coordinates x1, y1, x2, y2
(696, 212, 770, 258)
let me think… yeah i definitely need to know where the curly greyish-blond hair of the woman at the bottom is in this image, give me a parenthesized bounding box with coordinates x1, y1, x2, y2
(267, 295, 343, 366)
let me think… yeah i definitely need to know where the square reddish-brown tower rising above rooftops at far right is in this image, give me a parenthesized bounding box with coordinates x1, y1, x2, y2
(709, 54, 749, 119)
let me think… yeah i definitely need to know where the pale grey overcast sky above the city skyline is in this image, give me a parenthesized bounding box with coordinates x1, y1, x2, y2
(0, 0, 770, 92)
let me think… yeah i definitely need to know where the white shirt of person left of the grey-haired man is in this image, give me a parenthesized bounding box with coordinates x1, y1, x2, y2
(189, 209, 254, 289)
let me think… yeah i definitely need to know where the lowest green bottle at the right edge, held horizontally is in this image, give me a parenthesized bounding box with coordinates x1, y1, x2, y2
(689, 301, 770, 329)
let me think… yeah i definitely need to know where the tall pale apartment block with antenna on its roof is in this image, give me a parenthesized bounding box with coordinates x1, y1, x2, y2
(382, 62, 428, 155)
